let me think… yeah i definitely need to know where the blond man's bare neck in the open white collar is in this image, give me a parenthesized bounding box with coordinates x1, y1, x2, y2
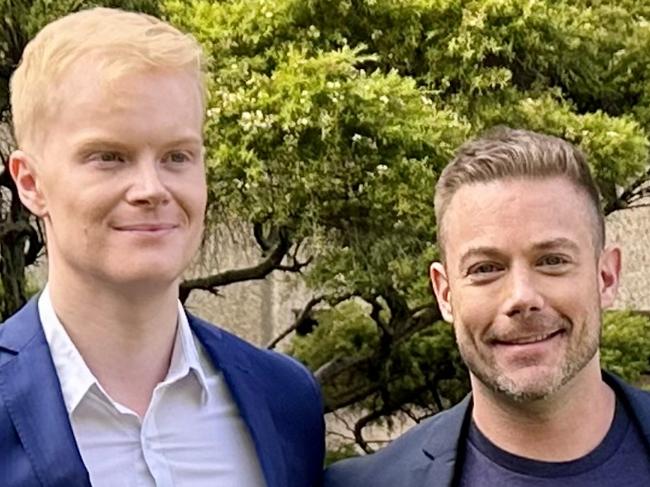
(49, 269, 178, 416)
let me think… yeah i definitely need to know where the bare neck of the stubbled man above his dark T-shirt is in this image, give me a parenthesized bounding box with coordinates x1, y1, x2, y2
(472, 362, 616, 462)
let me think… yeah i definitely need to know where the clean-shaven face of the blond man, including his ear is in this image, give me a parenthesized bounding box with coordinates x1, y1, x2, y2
(11, 61, 206, 285)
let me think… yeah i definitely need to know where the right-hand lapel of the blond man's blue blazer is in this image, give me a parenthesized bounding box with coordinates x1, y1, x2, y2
(188, 313, 288, 487)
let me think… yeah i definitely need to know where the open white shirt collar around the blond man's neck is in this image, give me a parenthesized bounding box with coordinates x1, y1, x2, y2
(38, 285, 208, 414)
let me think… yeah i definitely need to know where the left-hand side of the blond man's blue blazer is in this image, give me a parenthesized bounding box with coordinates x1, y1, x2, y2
(0, 298, 90, 487)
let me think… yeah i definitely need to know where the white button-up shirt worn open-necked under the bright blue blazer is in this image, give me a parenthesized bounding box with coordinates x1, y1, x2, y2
(38, 287, 265, 487)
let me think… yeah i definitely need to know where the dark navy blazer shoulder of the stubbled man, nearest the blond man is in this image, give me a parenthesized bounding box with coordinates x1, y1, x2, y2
(325, 398, 469, 487)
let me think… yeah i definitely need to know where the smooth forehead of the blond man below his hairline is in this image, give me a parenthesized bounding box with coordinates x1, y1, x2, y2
(43, 60, 203, 152)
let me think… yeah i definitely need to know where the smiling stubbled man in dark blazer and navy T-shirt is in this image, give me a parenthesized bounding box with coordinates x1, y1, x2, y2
(325, 128, 650, 487)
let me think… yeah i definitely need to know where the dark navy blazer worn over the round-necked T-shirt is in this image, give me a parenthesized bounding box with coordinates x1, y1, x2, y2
(324, 372, 650, 487)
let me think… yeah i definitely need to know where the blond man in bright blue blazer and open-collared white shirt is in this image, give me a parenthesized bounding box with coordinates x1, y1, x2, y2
(0, 8, 323, 487)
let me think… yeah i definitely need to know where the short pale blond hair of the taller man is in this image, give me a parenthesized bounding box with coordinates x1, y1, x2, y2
(10, 8, 206, 148)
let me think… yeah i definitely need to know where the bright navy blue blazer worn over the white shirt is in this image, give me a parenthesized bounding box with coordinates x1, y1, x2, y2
(0, 299, 324, 487)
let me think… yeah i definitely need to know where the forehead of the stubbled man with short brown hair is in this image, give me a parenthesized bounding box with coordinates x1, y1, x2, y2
(444, 177, 595, 260)
